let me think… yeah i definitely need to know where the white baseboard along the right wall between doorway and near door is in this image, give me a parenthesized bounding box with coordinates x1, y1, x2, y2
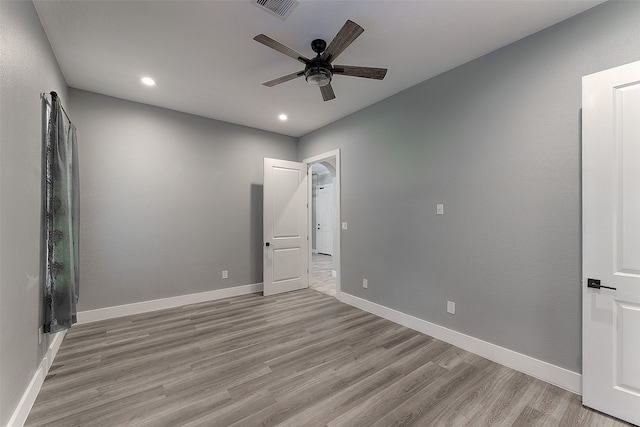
(339, 292, 582, 394)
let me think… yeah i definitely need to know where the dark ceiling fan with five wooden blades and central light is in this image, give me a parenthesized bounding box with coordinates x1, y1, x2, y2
(253, 20, 387, 101)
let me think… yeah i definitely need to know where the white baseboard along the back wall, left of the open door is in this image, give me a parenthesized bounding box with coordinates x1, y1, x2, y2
(78, 283, 262, 324)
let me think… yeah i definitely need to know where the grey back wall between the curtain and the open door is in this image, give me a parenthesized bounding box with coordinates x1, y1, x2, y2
(70, 89, 297, 311)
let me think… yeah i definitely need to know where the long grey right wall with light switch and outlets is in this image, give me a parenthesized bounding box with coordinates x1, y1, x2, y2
(298, 2, 640, 372)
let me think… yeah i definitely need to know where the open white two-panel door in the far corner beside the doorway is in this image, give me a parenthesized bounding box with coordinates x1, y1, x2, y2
(263, 158, 309, 296)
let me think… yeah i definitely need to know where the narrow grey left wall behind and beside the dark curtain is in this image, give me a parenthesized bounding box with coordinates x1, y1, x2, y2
(0, 1, 67, 426)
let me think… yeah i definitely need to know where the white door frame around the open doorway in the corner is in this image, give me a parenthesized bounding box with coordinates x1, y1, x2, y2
(303, 148, 342, 300)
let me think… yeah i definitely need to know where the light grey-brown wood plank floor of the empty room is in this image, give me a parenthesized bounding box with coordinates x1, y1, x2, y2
(26, 289, 627, 427)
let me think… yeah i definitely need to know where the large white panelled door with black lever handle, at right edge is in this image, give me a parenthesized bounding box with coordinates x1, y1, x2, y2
(582, 62, 640, 424)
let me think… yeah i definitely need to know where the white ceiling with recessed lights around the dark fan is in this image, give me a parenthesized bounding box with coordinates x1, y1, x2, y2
(35, 0, 604, 137)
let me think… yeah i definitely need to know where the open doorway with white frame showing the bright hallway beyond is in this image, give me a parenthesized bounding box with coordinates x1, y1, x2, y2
(304, 150, 340, 298)
